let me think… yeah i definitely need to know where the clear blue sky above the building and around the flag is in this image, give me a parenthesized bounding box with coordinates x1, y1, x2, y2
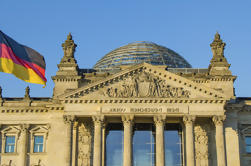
(0, 0, 251, 97)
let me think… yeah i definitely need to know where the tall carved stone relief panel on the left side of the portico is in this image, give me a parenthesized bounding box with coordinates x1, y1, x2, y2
(78, 122, 92, 166)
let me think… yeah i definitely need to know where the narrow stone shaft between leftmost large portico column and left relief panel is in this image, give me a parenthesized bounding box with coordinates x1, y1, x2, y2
(72, 121, 78, 166)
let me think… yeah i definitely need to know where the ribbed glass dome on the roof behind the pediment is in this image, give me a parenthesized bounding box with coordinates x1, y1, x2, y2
(94, 41, 191, 69)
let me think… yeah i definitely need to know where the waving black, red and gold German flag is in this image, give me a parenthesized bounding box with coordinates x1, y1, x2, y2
(0, 30, 47, 85)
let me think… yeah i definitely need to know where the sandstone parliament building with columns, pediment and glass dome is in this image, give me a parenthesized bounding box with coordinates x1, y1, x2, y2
(0, 33, 251, 166)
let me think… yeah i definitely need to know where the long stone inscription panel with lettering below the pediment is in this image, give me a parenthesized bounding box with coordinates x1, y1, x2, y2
(101, 106, 188, 114)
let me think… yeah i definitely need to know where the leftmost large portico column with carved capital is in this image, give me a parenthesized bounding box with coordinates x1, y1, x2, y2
(63, 115, 75, 166)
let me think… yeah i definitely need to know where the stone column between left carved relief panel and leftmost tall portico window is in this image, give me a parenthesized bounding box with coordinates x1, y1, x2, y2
(92, 116, 104, 166)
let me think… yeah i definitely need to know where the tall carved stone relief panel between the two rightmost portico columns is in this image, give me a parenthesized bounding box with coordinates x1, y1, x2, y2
(194, 124, 209, 166)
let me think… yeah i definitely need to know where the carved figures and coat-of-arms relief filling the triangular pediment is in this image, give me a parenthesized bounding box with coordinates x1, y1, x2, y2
(104, 72, 190, 98)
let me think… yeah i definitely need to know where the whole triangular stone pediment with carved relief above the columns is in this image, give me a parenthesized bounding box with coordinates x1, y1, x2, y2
(59, 63, 226, 100)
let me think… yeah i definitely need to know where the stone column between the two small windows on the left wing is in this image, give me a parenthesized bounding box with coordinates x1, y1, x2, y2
(18, 124, 29, 165)
